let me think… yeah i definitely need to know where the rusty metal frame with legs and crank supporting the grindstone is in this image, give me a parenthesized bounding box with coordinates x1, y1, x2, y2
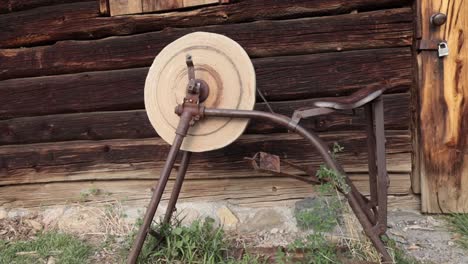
(127, 56, 392, 264)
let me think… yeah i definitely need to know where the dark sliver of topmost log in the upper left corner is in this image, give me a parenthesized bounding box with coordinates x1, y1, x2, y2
(0, 0, 90, 13)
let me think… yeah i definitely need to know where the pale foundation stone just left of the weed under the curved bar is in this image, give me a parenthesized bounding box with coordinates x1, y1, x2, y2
(240, 209, 284, 232)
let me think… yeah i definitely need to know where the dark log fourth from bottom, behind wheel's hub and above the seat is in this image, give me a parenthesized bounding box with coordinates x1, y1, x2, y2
(0, 48, 413, 119)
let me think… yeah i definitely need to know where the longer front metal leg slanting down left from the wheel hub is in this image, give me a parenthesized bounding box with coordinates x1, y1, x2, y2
(127, 114, 192, 264)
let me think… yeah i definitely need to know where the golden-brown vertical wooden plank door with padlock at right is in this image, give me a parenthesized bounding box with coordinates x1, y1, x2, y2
(415, 0, 468, 213)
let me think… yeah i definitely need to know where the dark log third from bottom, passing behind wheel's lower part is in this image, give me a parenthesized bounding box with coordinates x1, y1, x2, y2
(0, 93, 410, 145)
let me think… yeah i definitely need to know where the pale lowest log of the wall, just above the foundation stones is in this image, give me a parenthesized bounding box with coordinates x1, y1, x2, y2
(0, 178, 414, 210)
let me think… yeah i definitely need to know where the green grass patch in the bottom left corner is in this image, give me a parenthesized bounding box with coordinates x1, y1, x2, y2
(0, 232, 92, 264)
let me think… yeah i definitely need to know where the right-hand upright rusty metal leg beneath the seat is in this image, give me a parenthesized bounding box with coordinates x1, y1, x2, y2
(373, 97, 389, 234)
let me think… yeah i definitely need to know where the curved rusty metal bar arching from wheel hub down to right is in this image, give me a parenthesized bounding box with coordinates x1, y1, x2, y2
(204, 108, 392, 263)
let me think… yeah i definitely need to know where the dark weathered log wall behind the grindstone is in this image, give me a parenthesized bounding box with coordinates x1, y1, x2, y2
(0, 0, 415, 207)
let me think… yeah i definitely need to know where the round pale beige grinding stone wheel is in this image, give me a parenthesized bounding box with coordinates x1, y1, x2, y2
(145, 32, 255, 152)
